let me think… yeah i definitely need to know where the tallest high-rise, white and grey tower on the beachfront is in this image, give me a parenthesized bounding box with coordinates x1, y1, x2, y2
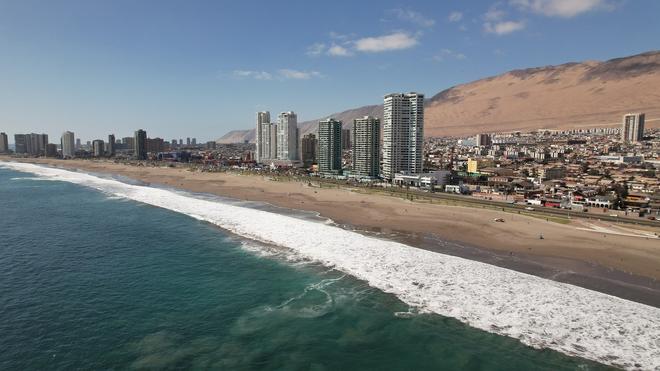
(383, 93, 424, 181)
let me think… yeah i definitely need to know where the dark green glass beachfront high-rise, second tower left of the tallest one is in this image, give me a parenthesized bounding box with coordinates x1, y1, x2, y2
(317, 118, 342, 174)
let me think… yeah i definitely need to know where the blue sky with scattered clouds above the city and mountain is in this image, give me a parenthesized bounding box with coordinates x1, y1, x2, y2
(0, 0, 660, 142)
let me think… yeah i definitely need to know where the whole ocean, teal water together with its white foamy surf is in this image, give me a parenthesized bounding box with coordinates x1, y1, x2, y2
(0, 164, 660, 370)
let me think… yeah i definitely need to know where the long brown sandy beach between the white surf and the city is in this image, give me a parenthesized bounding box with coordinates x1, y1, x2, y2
(5, 157, 660, 306)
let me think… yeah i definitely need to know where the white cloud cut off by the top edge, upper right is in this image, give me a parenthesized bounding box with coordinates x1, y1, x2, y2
(510, 0, 612, 18)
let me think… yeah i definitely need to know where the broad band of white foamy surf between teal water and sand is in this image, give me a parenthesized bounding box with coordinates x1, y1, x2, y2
(0, 163, 660, 370)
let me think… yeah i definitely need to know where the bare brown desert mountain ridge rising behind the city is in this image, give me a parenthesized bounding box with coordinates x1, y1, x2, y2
(218, 51, 660, 143)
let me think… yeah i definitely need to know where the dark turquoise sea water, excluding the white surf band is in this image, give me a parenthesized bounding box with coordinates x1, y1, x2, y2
(0, 169, 604, 370)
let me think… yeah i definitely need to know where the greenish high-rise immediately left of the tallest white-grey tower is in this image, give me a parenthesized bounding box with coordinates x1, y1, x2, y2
(352, 116, 380, 179)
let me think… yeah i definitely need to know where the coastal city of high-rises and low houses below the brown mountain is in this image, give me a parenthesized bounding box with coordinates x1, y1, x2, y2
(0, 93, 660, 220)
